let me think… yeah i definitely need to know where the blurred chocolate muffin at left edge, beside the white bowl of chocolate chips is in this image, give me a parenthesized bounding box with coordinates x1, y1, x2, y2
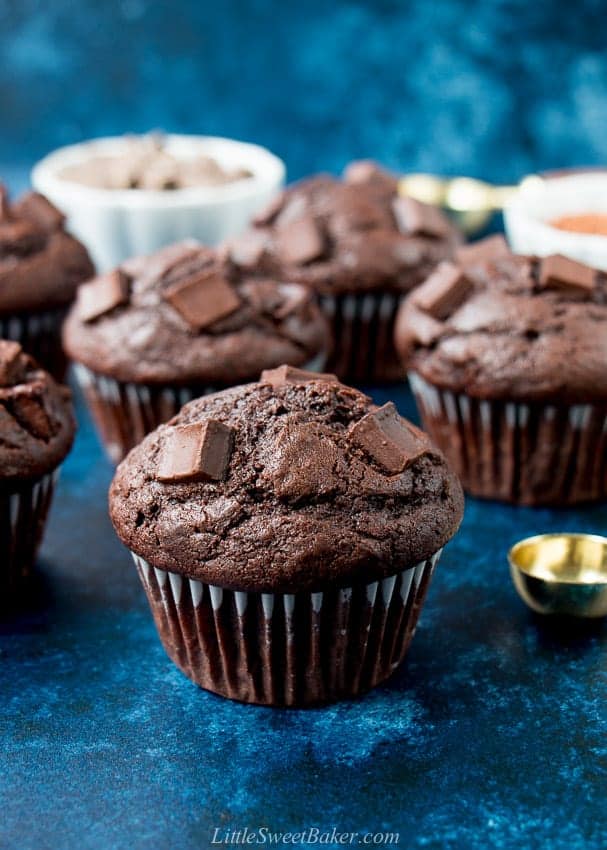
(0, 184, 95, 380)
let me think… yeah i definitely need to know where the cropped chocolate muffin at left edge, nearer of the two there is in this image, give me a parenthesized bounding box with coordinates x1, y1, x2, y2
(0, 340, 75, 592)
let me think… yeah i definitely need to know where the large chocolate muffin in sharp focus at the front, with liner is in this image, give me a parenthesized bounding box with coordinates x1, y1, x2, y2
(110, 366, 463, 705)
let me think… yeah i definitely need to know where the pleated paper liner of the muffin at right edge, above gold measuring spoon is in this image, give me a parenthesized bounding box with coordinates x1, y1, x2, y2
(409, 372, 607, 505)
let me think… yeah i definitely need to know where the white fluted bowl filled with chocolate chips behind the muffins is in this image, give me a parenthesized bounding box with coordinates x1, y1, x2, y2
(32, 134, 285, 272)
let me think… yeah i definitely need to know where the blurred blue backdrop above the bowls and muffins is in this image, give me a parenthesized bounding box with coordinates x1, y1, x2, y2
(0, 0, 607, 185)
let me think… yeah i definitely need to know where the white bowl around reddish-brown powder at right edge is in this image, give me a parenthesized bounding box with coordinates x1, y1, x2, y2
(504, 170, 607, 270)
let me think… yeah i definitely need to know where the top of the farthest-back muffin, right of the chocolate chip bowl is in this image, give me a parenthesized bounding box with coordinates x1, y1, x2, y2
(227, 162, 459, 295)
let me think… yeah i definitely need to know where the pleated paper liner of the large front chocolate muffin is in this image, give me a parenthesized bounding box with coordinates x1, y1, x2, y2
(132, 550, 442, 706)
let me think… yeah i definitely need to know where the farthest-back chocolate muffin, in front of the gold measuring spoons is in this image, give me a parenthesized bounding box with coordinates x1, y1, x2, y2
(228, 162, 459, 383)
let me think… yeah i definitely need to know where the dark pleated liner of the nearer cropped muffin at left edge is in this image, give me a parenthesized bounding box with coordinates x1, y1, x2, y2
(0, 469, 59, 605)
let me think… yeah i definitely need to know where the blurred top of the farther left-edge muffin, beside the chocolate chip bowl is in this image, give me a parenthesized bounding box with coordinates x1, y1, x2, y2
(0, 184, 95, 316)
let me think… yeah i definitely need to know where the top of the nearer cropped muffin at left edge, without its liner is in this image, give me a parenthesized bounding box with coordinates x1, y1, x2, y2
(0, 340, 76, 483)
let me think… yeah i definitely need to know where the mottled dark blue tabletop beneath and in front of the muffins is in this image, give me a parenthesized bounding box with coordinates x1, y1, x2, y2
(0, 391, 607, 850)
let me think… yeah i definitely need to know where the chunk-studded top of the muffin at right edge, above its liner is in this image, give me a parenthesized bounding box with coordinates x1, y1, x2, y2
(395, 236, 607, 403)
